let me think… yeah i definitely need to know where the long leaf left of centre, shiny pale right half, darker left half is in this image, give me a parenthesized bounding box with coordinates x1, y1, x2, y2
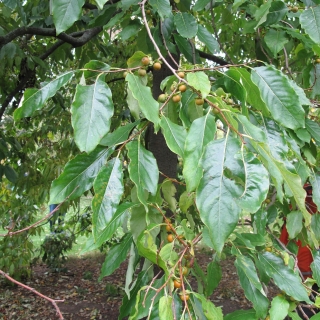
(92, 158, 124, 239)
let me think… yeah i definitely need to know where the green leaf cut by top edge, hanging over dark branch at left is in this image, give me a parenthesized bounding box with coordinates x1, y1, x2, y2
(52, 0, 85, 35)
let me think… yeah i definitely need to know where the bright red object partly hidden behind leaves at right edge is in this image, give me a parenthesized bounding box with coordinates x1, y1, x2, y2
(280, 184, 318, 277)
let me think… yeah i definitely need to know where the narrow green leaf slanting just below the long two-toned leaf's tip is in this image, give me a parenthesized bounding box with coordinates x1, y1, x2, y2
(95, 202, 137, 248)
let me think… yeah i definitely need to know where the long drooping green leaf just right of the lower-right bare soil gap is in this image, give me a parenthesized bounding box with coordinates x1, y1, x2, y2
(235, 256, 269, 319)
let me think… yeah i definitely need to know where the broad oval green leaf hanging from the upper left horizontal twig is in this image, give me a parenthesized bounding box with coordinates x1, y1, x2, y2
(71, 76, 114, 153)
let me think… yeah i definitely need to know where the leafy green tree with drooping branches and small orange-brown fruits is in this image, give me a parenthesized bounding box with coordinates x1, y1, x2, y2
(0, 0, 320, 319)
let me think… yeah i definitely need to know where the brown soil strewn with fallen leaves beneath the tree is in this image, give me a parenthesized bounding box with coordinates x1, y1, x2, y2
(0, 252, 277, 320)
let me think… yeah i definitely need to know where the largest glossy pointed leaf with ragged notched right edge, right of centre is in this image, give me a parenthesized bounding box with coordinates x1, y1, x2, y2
(196, 135, 242, 252)
